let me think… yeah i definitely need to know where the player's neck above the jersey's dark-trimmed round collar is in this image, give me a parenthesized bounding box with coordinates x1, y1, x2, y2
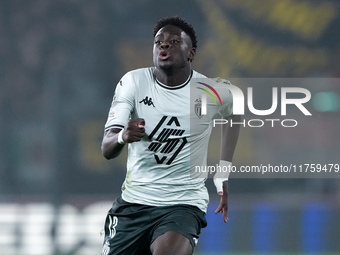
(155, 68, 191, 86)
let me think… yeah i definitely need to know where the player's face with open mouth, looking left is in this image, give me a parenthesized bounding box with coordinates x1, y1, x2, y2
(153, 25, 195, 69)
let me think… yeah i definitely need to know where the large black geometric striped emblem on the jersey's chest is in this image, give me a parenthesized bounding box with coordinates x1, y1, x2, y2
(148, 116, 187, 165)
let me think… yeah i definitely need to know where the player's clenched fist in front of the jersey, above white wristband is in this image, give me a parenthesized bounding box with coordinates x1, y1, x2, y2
(122, 118, 145, 143)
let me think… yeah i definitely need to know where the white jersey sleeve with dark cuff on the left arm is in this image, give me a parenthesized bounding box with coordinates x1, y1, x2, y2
(105, 73, 135, 130)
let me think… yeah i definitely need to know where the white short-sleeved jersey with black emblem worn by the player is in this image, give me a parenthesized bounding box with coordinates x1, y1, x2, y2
(105, 67, 232, 212)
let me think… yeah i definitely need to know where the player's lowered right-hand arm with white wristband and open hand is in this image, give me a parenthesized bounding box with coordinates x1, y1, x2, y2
(214, 115, 241, 222)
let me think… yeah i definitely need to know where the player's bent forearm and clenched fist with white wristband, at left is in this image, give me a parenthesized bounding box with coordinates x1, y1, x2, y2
(101, 118, 145, 159)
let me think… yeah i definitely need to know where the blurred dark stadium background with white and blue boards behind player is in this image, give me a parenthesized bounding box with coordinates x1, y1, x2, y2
(0, 0, 340, 255)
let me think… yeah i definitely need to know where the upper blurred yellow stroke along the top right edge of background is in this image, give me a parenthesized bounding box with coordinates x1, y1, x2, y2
(223, 0, 336, 39)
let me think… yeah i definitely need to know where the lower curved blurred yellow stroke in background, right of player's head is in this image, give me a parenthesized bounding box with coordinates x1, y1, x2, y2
(199, 0, 329, 77)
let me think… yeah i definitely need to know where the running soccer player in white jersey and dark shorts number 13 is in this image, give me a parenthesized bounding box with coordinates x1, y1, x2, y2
(102, 17, 238, 255)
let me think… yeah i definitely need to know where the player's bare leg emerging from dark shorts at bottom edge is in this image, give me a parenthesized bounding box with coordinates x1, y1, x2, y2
(150, 231, 193, 255)
